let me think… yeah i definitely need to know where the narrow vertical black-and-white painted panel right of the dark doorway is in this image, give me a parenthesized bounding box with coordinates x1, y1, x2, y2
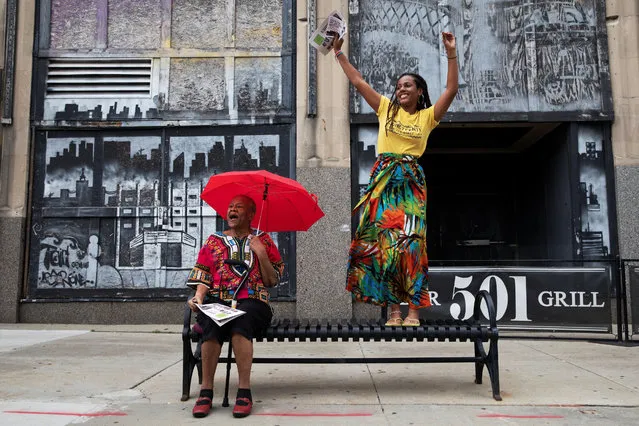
(575, 124, 611, 259)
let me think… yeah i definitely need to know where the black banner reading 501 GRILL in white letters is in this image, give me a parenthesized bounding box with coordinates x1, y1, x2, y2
(429, 267, 612, 329)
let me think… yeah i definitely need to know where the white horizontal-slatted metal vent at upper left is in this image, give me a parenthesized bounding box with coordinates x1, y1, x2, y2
(47, 59, 152, 98)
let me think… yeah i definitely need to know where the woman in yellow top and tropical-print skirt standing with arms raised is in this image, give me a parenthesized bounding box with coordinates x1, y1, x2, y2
(333, 32, 458, 326)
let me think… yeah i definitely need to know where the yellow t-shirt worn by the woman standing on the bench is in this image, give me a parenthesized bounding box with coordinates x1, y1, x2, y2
(377, 95, 439, 157)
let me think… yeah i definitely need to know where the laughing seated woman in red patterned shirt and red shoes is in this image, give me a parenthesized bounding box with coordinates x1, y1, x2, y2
(187, 195, 284, 417)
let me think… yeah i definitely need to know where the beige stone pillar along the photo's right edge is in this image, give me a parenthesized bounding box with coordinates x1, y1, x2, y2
(606, 0, 639, 259)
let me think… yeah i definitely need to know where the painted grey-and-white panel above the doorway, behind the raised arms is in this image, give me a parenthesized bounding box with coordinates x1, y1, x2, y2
(350, 0, 609, 113)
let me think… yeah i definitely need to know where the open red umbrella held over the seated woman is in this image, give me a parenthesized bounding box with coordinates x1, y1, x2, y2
(201, 170, 324, 232)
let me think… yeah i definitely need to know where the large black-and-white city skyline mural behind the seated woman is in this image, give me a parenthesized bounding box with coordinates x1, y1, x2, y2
(30, 132, 291, 295)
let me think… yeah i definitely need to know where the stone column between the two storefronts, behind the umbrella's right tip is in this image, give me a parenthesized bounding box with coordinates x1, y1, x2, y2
(296, 0, 352, 319)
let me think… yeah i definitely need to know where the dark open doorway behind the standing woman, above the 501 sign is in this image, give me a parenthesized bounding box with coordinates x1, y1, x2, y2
(420, 123, 574, 262)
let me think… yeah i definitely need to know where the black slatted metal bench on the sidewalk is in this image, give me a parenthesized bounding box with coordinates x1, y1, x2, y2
(182, 290, 501, 407)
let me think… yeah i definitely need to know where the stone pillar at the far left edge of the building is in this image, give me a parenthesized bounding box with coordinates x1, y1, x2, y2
(0, 0, 35, 322)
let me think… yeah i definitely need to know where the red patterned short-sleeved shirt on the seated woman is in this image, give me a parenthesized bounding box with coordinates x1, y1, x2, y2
(187, 230, 284, 303)
